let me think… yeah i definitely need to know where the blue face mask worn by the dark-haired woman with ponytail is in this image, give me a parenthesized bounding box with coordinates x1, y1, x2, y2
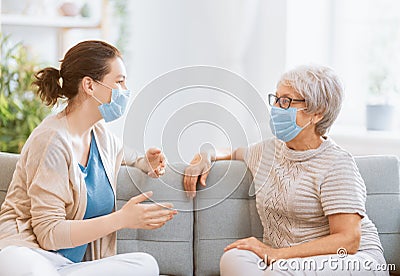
(92, 82, 131, 123)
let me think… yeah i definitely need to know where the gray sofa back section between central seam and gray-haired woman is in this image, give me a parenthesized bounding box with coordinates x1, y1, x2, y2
(194, 161, 262, 275)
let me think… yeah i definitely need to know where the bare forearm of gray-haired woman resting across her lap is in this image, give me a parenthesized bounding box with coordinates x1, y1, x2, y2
(272, 233, 360, 259)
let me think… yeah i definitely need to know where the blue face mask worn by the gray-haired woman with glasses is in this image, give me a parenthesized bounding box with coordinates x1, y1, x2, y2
(269, 106, 311, 142)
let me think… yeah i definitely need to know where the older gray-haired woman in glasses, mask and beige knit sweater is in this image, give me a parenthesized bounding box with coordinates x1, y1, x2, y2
(184, 66, 387, 276)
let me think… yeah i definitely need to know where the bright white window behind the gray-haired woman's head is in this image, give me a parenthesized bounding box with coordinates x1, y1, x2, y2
(287, 0, 400, 131)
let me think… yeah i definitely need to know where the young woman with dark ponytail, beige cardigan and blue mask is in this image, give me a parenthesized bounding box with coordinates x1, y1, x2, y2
(0, 41, 176, 276)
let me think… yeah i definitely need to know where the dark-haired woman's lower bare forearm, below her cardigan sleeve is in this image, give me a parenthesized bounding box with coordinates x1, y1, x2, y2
(71, 211, 123, 246)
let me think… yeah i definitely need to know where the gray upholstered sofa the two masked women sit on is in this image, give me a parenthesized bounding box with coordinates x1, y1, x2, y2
(0, 153, 400, 276)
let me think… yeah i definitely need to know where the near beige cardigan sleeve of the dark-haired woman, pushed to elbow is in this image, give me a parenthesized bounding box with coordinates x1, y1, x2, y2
(25, 133, 74, 250)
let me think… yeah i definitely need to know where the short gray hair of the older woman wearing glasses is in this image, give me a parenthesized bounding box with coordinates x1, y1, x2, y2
(278, 65, 344, 135)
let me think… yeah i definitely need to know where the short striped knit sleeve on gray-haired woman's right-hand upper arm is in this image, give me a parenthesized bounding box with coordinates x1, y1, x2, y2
(320, 153, 366, 217)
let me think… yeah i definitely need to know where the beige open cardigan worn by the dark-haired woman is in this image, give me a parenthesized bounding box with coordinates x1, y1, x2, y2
(0, 112, 138, 260)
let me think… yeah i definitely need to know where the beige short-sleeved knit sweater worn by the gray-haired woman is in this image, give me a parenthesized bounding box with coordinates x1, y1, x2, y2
(245, 138, 383, 252)
